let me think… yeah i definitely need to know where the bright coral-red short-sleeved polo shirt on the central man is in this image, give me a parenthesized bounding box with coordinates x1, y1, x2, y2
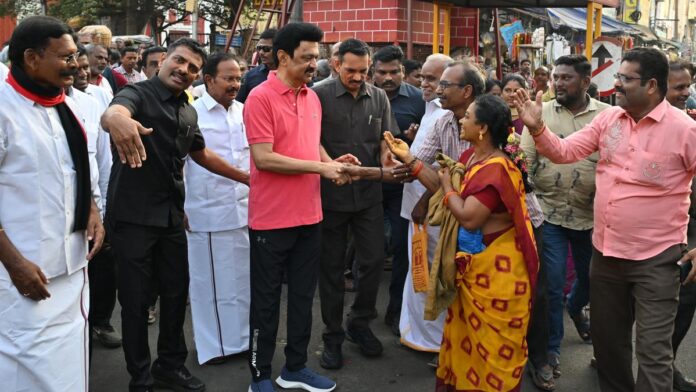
(244, 71, 322, 230)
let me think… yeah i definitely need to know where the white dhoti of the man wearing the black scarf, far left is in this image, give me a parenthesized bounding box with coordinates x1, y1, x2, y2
(0, 268, 89, 392)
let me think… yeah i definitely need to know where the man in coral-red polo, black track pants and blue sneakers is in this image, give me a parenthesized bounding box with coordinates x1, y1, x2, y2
(244, 23, 358, 392)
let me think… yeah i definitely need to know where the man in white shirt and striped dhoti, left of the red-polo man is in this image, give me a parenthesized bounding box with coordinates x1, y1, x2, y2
(184, 54, 250, 364)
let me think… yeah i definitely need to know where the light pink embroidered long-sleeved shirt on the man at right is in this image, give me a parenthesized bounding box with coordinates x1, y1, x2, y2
(534, 100, 696, 261)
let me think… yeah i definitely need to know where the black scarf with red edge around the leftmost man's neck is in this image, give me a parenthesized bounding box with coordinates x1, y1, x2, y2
(7, 65, 92, 231)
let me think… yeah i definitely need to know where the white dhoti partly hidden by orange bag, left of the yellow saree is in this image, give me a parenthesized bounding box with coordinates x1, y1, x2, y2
(399, 221, 445, 352)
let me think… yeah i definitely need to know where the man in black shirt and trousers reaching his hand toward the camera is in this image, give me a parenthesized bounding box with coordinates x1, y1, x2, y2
(102, 38, 248, 391)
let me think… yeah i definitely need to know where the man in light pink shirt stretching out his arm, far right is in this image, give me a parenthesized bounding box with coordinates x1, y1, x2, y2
(515, 48, 696, 392)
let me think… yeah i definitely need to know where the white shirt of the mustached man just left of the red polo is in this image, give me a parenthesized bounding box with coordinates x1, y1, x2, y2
(184, 91, 250, 232)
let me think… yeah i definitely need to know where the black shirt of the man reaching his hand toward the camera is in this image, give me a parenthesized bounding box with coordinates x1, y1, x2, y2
(106, 76, 205, 227)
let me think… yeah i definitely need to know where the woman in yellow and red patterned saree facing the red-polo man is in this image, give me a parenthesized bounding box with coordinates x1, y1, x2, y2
(436, 95, 538, 392)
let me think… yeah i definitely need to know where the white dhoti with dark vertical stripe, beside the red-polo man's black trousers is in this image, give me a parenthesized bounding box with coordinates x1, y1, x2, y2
(187, 226, 251, 364)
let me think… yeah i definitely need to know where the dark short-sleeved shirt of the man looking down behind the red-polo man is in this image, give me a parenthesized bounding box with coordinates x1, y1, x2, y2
(314, 78, 399, 212)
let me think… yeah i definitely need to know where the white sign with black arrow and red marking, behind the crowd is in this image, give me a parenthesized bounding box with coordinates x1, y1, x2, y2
(590, 37, 623, 97)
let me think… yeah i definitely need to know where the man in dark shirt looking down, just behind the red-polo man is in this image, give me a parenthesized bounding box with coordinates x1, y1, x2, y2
(315, 39, 398, 369)
